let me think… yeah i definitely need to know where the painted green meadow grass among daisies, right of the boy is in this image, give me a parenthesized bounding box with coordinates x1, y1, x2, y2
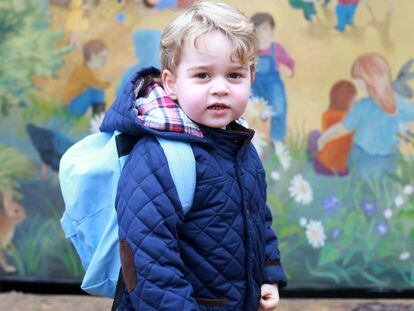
(266, 135, 414, 288)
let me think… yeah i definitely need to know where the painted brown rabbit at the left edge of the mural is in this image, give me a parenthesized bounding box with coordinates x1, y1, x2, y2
(0, 191, 26, 273)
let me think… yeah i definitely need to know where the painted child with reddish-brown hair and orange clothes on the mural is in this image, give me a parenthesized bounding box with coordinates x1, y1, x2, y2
(314, 80, 357, 176)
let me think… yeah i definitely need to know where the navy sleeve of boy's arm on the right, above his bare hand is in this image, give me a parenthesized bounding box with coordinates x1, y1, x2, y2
(260, 167, 287, 288)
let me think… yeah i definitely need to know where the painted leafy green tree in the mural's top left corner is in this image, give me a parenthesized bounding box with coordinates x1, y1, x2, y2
(0, 0, 68, 115)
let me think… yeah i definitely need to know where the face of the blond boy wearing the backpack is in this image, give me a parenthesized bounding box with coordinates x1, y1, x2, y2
(162, 31, 252, 128)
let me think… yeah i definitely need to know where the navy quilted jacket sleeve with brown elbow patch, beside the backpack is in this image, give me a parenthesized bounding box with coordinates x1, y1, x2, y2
(116, 137, 199, 311)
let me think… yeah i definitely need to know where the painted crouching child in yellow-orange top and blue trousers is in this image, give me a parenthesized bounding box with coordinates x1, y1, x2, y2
(63, 40, 110, 117)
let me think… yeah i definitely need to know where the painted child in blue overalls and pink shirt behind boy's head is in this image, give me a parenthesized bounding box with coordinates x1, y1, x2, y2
(251, 13, 295, 141)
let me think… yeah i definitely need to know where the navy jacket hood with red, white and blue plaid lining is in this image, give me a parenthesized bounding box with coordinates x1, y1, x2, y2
(100, 67, 210, 142)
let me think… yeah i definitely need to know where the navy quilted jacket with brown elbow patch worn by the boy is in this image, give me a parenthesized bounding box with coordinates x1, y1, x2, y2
(101, 68, 286, 311)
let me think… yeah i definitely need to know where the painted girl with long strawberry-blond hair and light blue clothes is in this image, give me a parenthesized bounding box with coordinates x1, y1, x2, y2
(318, 53, 414, 178)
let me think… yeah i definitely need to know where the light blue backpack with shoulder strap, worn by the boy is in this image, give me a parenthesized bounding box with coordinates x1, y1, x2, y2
(59, 132, 196, 298)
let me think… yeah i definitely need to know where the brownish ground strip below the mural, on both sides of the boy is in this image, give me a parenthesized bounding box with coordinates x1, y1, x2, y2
(0, 292, 414, 311)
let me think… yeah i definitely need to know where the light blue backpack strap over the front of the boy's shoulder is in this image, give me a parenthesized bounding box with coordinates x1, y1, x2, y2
(157, 136, 196, 214)
